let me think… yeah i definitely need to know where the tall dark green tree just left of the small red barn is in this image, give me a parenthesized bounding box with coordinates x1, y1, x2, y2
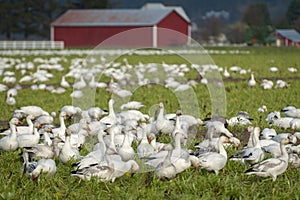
(242, 3, 272, 43)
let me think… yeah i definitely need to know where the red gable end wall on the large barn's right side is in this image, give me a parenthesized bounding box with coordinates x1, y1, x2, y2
(157, 11, 189, 46)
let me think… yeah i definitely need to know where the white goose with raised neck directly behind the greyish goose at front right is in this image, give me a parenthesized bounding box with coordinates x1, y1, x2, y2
(229, 127, 265, 165)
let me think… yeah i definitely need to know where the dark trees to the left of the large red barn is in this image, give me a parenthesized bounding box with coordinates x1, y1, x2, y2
(0, 0, 116, 40)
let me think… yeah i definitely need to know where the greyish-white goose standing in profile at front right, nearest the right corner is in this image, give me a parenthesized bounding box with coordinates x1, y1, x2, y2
(245, 138, 289, 181)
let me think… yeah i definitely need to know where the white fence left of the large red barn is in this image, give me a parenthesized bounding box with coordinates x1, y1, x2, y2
(0, 41, 64, 49)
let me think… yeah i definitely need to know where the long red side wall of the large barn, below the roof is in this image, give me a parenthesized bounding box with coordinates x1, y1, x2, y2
(54, 26, 152, 47)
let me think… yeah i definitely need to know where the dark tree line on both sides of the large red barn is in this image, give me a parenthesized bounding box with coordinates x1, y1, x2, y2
(0, 0, 300, 43)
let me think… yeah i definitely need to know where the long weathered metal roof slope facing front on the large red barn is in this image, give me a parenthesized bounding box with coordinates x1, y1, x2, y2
(52, 9, 178, 26)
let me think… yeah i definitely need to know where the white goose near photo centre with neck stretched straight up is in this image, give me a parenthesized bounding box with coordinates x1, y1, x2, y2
(155, 102, 175, 135)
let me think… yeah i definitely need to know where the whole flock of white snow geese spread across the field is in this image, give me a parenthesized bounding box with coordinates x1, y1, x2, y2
(0, 50, 300, 182)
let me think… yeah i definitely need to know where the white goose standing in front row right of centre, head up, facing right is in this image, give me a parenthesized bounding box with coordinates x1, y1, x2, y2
(198, 135, 228, 174)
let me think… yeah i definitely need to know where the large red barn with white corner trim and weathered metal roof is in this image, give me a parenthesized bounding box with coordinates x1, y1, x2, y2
(51, 4, 191, 47)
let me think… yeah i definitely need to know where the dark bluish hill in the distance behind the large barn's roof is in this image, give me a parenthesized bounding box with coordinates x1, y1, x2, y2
(115, 0, 291, 24)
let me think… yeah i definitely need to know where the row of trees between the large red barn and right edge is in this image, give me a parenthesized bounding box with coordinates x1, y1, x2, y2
(198, 0, 300, 44)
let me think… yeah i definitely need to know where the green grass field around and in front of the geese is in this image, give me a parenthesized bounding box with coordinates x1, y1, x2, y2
(0, 47, 300, 199)
